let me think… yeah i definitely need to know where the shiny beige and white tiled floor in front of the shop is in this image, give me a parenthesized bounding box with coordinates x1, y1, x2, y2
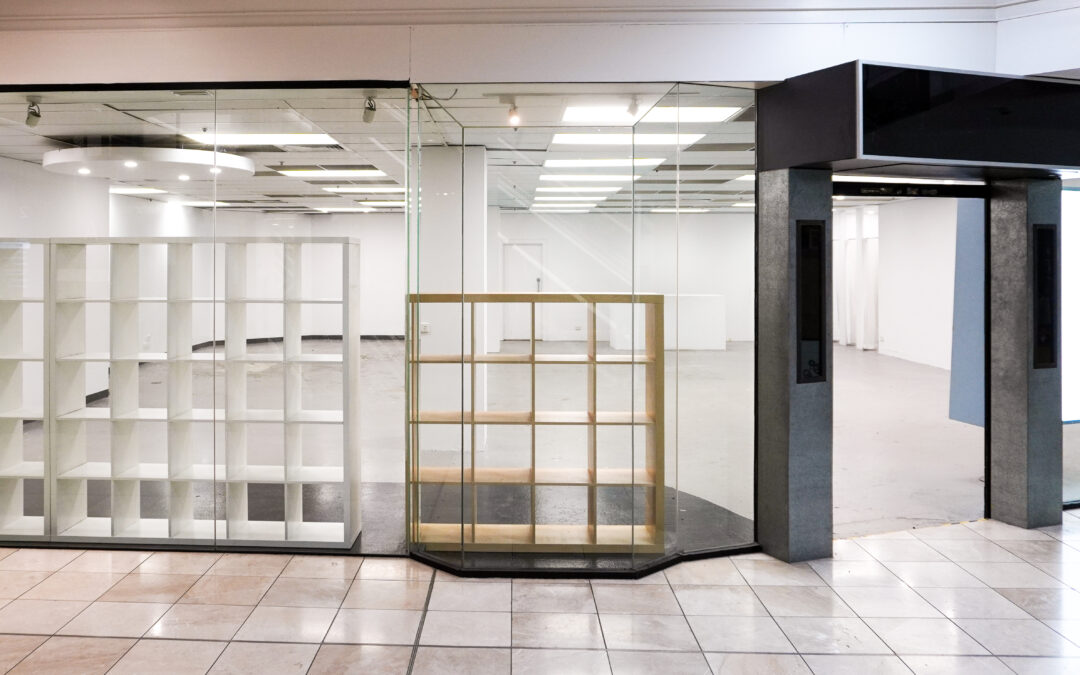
(0, 512, 1080, 675)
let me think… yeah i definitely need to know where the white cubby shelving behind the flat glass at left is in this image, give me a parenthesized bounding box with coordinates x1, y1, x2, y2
(0, 238, 361, 548)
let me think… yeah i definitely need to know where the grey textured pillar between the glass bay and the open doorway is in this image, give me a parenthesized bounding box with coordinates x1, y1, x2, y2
(755, 168, 833, 562)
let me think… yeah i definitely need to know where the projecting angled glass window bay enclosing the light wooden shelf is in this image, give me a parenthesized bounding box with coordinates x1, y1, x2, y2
(407, 84, 754, 570)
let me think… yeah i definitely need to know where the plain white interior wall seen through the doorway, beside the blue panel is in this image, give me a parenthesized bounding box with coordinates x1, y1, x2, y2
(878, 199, 957, 369)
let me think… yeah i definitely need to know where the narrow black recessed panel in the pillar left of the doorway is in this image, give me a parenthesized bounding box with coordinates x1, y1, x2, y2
(795, 220, 827, 384)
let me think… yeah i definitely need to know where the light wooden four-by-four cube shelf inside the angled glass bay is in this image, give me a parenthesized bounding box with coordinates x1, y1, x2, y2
(407, 293, 664, 553)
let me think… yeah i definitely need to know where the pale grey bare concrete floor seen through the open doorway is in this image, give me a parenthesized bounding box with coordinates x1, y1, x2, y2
(833, 346, 984, 537)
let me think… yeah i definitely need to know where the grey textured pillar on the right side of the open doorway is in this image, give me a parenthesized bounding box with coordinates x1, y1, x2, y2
(987, 179, 1062, 527)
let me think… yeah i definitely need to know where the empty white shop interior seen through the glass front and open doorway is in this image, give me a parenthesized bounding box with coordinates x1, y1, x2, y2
(0, 83, 1080, 572)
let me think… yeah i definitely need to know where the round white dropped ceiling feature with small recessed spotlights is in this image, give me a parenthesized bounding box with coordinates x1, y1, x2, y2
(41, 147, 255, 181)
